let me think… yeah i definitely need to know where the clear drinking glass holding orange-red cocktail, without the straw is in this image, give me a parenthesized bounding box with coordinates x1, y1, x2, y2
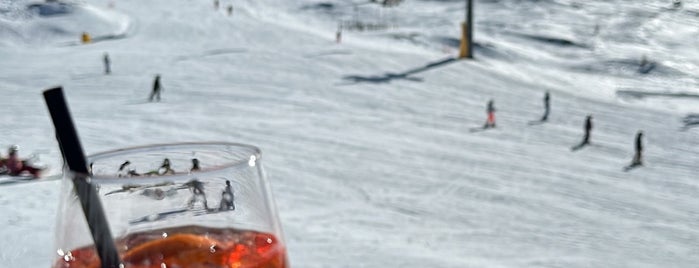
(53, 142, 288, 268)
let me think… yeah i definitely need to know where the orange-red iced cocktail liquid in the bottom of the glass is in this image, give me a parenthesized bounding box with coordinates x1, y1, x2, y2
(54, 226, 288, 268)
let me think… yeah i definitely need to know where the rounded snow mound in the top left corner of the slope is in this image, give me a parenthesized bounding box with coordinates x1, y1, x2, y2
(0, 1, 131, 46)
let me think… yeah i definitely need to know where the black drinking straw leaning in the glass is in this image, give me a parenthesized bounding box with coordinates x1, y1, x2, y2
(44, 87, 121, 268)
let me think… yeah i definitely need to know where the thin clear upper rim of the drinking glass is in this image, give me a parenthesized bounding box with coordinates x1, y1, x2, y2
(82, 141, 262, 180)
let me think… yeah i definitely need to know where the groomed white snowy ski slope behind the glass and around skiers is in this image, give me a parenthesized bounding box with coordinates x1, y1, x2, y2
(0, 0, 699, 268)
